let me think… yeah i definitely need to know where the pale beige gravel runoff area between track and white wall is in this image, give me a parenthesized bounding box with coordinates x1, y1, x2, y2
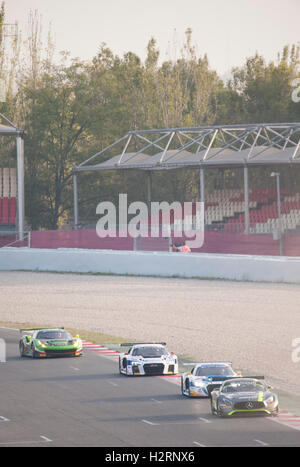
(0, 272, 300, 394)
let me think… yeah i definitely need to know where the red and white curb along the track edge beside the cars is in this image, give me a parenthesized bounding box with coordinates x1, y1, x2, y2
(83, 341, 300, 431)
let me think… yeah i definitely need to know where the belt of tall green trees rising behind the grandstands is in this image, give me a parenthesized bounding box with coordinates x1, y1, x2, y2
(0, 5, 300, 229)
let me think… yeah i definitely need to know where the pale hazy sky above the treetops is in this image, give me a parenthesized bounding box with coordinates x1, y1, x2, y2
(4, 0, 300, 76)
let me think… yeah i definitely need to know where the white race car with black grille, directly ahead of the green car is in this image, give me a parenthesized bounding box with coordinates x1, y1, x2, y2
(119, 342, 178, 376)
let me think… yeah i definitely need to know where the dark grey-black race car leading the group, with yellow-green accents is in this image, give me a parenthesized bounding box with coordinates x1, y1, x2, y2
(211, 377, 278, 417)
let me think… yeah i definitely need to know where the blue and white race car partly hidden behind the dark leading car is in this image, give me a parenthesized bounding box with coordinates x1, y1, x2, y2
(181, 362, 241, 397)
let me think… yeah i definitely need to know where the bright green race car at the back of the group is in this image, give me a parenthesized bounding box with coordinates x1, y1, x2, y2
(19, 328, 82, 358)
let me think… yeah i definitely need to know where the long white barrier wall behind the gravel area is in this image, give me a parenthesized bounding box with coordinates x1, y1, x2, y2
(0, 248, 300, 283)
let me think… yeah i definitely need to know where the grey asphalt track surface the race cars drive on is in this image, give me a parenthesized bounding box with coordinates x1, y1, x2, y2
(0, 329, 300, 448)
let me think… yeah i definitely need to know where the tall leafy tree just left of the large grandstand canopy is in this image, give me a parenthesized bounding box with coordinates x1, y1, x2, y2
(23, 62, 102, 229)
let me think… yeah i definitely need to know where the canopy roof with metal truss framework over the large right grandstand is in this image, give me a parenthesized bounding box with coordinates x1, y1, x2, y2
(74, 123, 300, 172)
